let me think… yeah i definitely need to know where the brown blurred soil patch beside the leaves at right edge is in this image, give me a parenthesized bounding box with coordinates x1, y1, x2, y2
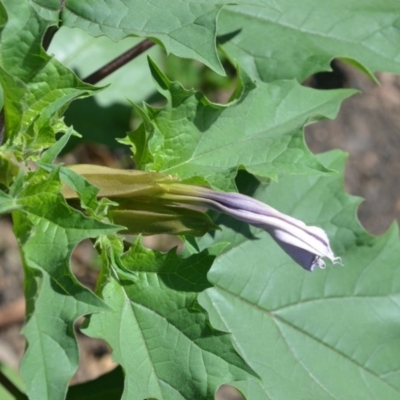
(306, 64, 400, 234)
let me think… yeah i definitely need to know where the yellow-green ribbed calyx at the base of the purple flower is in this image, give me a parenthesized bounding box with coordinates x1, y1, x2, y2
(62, 164, 218, 236)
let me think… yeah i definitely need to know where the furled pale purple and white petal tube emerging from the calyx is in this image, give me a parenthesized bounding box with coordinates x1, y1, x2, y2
(160, 183, 341, 271)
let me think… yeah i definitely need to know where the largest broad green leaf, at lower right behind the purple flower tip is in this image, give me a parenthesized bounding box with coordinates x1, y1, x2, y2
(199, 151, 400, 400)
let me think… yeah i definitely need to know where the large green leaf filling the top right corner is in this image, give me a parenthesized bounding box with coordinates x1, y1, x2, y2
(218, 0, 400, 82)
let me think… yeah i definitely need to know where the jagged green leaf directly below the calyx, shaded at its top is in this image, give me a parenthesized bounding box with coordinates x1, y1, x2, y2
(85, 241, 255, 400)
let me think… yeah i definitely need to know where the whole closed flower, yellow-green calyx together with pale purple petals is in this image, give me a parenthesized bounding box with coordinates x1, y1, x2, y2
(63, 164, 341, 271)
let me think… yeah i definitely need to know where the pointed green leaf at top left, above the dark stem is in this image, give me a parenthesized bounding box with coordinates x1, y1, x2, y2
(34, 0, 275, 75)
